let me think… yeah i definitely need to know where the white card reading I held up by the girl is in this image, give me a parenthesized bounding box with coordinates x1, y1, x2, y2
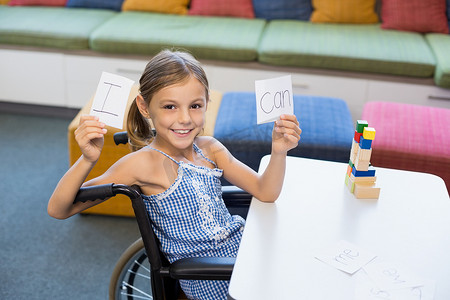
(90, 72, 134, 129)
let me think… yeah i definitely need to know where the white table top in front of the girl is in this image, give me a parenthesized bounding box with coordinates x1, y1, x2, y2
(229, 156, 450, 300)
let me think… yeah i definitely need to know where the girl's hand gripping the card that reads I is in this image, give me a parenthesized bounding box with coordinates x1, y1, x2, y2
(75, 115, 107, 163)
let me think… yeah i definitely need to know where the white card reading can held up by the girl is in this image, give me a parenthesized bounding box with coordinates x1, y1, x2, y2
(255, 75, 294, 124)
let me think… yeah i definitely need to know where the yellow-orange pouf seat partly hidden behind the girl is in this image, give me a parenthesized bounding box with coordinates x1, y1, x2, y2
(68, 85, 222, 217)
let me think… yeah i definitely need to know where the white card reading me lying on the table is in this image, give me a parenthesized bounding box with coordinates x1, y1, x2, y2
(315, 240, 376, 274)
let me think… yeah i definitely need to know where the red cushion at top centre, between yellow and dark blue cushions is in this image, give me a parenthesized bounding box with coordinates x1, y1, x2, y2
(189, 0, 255, 18)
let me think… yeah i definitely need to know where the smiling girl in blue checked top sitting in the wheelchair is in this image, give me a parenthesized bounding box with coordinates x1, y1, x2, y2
(48, 50, 301, 299)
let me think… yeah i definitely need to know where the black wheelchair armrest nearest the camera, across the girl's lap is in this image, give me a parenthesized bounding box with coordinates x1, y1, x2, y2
(169, 257, 236, 280)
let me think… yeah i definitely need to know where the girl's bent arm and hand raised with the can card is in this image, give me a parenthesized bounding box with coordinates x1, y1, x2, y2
(214, 115, 301, 202)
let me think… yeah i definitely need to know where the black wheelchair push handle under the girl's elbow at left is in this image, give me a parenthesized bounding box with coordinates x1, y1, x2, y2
(73, 183, 141, 203)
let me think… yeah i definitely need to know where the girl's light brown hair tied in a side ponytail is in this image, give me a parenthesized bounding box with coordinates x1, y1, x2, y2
(127, 50, 209, 151)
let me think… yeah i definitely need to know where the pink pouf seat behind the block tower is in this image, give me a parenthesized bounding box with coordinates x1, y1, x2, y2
(362, 102, 450, 195)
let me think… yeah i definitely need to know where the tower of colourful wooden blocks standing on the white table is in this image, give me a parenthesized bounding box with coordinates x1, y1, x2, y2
(345, 120, 380, 199)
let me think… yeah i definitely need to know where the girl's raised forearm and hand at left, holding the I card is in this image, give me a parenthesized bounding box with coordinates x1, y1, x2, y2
(47, 116, 110, 219)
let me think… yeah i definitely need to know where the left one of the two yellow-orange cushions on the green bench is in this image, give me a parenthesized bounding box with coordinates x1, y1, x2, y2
(122, 0, 189, 15)
